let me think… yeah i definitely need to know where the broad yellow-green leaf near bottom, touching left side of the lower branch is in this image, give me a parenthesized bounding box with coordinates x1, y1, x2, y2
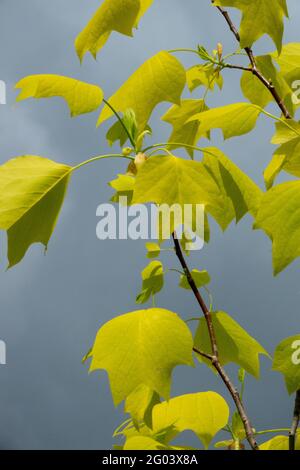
(152, 392, 229, 448)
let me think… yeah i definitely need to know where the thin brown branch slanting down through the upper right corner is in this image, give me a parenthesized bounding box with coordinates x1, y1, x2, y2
(212, 0, 291, 119)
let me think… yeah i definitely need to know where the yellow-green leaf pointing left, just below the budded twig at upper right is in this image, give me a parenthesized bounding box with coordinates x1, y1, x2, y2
(187, 103, 261, 139)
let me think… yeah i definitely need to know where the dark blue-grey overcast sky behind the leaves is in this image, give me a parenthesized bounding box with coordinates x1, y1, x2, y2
(0, 0, 300, 449)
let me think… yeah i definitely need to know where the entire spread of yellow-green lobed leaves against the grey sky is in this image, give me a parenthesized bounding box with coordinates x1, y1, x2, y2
(0, 0, 300, 450)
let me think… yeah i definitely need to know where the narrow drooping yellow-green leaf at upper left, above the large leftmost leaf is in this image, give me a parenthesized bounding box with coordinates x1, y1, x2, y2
(16, 75, 103, 117)
